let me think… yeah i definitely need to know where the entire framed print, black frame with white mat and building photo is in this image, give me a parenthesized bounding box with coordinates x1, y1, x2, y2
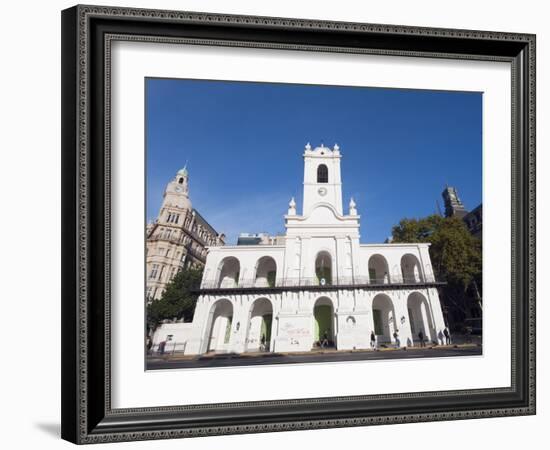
(62, 6, 535, 443)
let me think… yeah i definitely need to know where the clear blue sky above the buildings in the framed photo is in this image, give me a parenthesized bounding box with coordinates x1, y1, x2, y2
(145, 79, 482, 243)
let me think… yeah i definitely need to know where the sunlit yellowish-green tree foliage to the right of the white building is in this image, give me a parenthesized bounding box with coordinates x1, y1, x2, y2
(392, 215, 482, 293)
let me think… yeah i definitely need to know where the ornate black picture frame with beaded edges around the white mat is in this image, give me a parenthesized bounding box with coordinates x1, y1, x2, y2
(62, 6, 535, 444)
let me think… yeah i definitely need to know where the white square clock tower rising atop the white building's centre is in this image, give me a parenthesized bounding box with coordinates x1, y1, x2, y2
(302, 142, 342, 216)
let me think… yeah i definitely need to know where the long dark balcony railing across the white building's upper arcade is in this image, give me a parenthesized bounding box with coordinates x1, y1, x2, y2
(200, 276, 445, 291)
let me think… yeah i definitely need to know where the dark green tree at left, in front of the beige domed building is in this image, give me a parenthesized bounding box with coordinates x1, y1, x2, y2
(147, 268, 202, 329)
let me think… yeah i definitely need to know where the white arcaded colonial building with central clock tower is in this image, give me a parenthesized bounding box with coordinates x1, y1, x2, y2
(154, 144, 445, 354)
